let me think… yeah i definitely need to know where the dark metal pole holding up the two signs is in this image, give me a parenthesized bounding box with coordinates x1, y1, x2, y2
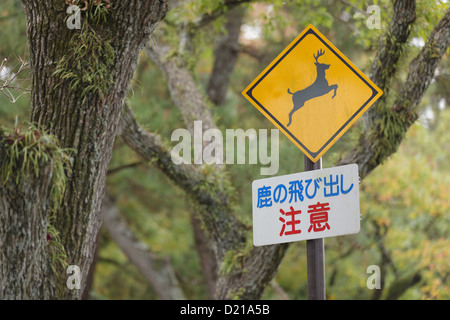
(305, 156, 325, 300)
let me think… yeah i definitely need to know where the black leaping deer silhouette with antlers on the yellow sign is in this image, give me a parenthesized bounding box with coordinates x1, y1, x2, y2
(287, 49, 337, 127)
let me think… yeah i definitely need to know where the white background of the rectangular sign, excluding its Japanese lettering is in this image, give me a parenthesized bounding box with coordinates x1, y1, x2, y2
(252, 164, 361, 246)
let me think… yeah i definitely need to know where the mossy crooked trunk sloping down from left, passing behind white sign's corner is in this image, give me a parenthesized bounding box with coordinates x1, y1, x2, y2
(121, 105, 289, 299)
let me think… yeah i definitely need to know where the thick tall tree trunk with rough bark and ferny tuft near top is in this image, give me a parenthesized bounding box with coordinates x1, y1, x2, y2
(0, 0, 167, 298)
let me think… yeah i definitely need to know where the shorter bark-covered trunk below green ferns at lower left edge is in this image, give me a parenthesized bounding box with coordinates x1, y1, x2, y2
(0, 159, 54, 300)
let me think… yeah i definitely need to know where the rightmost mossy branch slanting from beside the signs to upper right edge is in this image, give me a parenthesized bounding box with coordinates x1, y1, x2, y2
(339, 1, 450, 178)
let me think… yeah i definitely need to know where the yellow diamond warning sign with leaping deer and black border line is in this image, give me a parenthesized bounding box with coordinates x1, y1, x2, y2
(242, 25, 383, 162)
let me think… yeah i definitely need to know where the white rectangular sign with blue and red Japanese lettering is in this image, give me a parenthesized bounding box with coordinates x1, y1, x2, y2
(252, 164, 360, 246)
